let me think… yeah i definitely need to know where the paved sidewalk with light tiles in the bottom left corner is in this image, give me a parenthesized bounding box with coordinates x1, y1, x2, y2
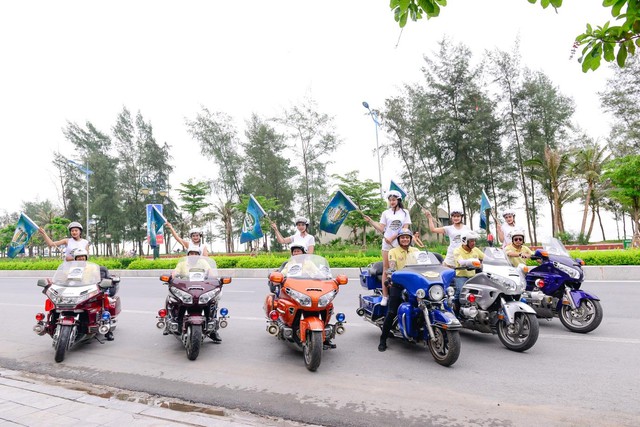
(0, 369, 310, 427)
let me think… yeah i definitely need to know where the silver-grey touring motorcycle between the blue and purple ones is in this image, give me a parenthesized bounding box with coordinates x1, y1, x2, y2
(456, 247, 539, 352)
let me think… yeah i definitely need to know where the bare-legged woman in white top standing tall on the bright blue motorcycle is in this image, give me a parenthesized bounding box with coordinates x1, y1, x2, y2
(362, 190, 411, 306)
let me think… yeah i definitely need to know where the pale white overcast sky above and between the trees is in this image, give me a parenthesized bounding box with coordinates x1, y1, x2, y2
(0, 0, 615, 242)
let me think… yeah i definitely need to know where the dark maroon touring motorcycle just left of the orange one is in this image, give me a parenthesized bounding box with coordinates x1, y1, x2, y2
(156, 256, 231, 360)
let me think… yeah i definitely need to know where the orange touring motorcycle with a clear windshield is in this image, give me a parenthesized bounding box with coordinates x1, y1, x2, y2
(264, 254, 349, 371)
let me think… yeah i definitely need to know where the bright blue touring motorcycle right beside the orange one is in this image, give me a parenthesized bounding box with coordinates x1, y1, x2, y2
(356, 252, 461, 366)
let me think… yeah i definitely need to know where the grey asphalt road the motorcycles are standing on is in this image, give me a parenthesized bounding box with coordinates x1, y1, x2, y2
(0, 278, 640, 426)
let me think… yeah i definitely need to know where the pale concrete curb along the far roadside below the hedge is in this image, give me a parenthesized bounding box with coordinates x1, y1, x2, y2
(0, 265, 640, 281)
